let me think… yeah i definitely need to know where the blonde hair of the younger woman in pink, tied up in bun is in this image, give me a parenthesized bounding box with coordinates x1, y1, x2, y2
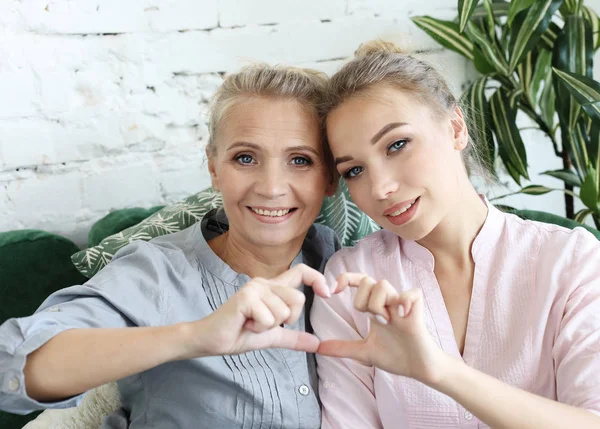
(321, 40, 491, 179)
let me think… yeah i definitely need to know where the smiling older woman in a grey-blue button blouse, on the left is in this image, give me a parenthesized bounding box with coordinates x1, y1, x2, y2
(0, 66, 338, 429)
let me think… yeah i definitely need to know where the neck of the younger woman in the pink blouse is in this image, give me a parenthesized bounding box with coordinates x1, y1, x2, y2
(418, 183, 488, 270)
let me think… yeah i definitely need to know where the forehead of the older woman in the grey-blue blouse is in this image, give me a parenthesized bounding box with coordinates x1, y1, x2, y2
(219, 98, 321, 145)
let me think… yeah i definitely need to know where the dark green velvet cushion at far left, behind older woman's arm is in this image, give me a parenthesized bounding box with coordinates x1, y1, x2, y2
(0, 230, 86, 429)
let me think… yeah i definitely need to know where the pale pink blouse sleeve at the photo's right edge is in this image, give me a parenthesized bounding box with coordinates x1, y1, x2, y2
(553, 231, 600, 415)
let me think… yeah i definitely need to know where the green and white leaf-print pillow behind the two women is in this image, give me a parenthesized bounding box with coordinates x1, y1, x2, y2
(71, 180, 379, 277)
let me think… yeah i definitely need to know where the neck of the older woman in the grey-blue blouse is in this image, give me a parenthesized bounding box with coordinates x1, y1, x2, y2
(208, 230, 302, 279)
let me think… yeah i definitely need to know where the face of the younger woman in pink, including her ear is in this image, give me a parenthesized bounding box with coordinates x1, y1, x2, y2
(327, 87, 468, 240)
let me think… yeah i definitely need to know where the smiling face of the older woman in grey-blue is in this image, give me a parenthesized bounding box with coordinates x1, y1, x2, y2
(209, 98, 331, 246)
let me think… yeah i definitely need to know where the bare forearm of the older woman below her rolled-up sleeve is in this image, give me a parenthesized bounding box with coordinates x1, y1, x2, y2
(23, 324, 186, 402)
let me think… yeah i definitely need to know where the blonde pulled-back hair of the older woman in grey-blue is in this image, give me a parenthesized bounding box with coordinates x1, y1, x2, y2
(206, 64, 335, 179)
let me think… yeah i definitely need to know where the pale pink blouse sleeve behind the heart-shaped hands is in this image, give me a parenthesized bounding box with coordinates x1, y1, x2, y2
(311, 253, 383, 429)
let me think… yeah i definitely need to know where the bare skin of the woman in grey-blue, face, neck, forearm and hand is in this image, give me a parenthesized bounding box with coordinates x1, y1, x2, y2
(24, 94, 333, 401)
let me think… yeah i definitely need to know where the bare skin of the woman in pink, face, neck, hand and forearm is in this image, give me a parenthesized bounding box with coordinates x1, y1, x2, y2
(318, 86, 600, 428)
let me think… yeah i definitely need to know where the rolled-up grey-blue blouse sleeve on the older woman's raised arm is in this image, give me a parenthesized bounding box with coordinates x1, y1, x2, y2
(0, 242, 174, 414)
